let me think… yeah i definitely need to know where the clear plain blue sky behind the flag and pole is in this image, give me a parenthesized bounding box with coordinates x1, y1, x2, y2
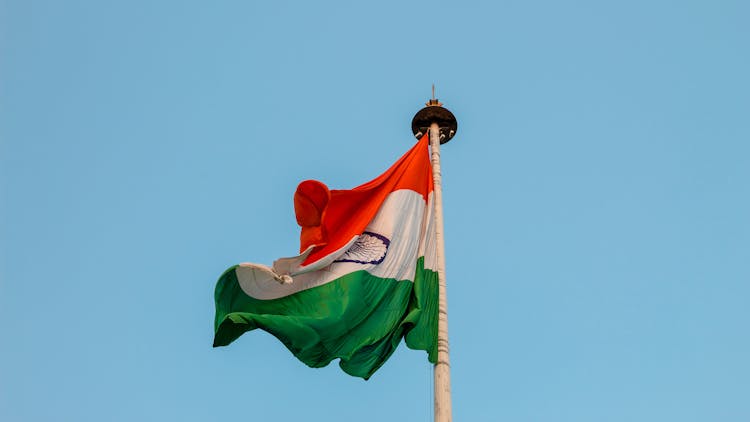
(0, 0, 750, 422)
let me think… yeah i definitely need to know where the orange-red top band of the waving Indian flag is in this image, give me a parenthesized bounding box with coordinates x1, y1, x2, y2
(294, 134, 433, 265)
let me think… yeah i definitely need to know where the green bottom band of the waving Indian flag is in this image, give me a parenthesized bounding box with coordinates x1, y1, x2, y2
(214, 258, 438, 379)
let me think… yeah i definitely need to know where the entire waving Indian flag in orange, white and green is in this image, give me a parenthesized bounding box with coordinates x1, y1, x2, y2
(214, 136, 438, 379)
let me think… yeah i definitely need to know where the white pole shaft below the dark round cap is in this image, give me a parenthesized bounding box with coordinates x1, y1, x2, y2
(430, 123, 453, 422)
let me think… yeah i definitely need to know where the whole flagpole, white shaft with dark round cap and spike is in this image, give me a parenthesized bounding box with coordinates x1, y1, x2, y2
(412, 91, 458, 422)
